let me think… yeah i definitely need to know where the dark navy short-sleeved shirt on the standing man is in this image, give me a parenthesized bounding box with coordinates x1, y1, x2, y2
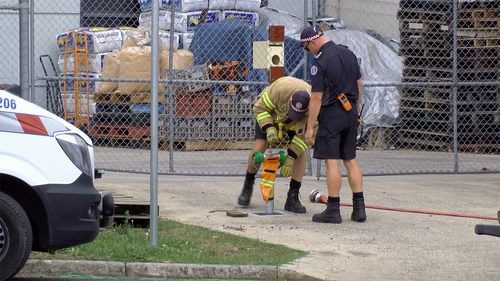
(311, 41, 361, 106)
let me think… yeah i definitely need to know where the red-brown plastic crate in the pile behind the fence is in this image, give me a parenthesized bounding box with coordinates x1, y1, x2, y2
(174, 92, 212, 117)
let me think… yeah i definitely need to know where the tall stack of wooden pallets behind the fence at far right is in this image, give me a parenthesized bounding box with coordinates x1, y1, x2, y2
(398, 0, 500, 153)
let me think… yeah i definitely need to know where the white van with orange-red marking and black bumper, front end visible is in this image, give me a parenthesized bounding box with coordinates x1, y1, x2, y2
(0, 87, 114, 281)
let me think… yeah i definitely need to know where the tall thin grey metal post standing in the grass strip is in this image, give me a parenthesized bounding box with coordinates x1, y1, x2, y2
(149, 1, 160, 247)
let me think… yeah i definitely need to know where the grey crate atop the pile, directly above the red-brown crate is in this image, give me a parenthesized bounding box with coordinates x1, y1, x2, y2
(172, 64, 212, 93)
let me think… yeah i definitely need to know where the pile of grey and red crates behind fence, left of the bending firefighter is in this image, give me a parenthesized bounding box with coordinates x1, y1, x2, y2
(155, 61, 257, 150)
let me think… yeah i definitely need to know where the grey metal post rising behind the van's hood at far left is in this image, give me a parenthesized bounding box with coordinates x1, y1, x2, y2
(19, 0, 30, 100)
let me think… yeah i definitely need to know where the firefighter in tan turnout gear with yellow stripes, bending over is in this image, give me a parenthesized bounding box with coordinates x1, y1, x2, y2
(238, 77, 317, 213)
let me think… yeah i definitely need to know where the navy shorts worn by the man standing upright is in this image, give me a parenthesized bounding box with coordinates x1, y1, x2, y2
(313, 101, 358, 160)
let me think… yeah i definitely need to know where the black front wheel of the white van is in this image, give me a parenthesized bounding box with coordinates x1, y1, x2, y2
(0, 192, 33, 281)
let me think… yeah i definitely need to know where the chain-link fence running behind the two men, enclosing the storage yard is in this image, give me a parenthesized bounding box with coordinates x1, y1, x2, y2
(4, 0, 500, 177)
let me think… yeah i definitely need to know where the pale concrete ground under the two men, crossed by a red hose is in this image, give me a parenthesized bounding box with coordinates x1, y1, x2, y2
(20, 172, 500, 280)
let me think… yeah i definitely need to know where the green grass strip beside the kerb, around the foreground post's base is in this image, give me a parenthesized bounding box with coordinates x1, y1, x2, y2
(30, 214, 307, 266)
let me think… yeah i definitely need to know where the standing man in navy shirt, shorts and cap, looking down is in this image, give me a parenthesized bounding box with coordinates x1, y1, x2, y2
(299, 26, 366, 223)
